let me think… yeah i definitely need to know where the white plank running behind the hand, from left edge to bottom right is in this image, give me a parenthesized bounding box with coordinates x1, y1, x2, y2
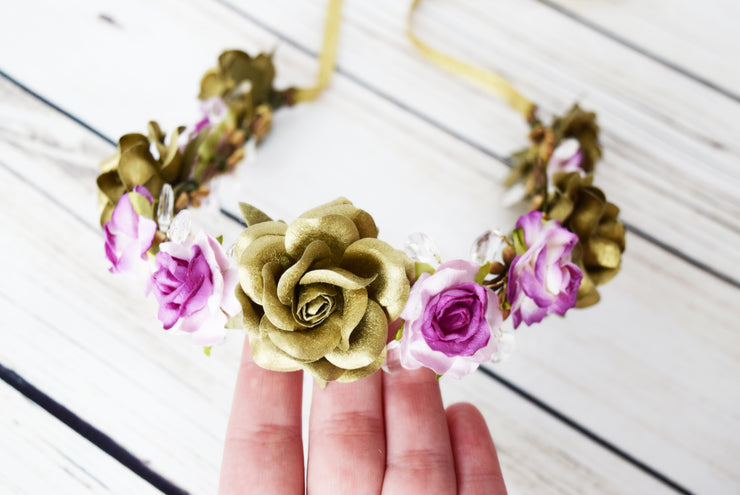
(0, 78, 684, 494)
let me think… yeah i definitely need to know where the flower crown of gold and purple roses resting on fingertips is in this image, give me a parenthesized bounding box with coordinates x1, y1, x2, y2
(97, 2, 624, 382)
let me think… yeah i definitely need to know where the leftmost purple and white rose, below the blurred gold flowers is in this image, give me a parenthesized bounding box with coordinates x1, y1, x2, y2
(103, 186, 157, 275)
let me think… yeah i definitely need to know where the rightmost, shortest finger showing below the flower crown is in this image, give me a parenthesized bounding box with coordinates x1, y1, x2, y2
(447, 403, 506, 495)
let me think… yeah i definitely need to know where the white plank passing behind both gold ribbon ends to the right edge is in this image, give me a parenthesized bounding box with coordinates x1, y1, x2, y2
(197, 0, 740, 282)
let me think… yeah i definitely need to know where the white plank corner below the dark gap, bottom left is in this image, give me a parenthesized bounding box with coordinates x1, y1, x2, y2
(0, 382, 159, 495)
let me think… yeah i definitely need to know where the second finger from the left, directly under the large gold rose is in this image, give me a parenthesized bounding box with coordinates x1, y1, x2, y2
(307, 373, 385, 495)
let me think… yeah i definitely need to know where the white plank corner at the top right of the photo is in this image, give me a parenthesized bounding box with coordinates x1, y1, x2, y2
(545, 0, 740, 95)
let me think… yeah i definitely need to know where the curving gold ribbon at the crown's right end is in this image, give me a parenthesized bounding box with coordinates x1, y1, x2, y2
(406, 0, 537, 122)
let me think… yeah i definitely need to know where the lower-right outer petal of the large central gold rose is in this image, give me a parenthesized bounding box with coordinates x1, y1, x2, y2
(326, 300, 388, 369)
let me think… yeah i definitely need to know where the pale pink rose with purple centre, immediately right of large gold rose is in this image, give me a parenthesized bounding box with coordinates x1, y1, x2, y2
(388, 260, 502, 378)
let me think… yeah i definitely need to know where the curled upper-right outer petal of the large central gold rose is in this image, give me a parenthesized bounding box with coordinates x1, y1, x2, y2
(340, 238, 410, 321)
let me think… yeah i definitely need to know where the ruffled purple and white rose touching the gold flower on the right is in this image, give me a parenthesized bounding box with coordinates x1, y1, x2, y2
(507, 211, 583, 328)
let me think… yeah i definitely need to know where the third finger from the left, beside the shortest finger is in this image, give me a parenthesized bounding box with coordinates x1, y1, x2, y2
(383, 368, 455, 495)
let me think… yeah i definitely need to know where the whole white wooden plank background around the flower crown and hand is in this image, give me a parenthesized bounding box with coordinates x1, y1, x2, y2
(0, 0, 740, 494)
